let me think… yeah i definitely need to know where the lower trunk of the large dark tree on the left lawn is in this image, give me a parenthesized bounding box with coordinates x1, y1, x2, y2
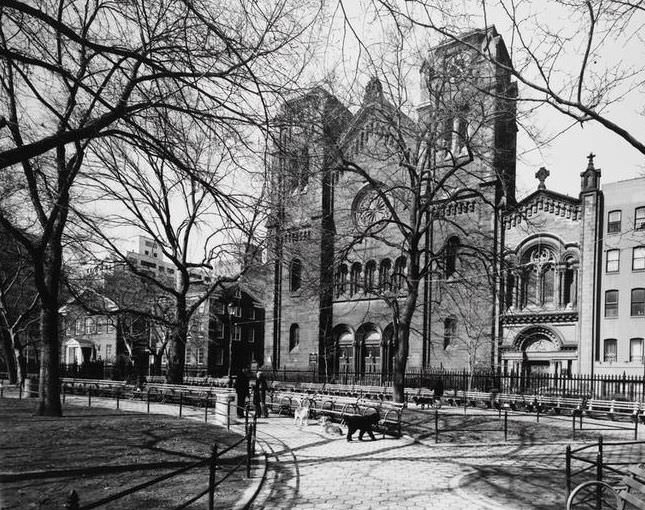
(38, 300, 63, 416)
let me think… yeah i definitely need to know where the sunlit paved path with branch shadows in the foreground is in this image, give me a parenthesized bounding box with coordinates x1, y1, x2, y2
(247, 410, 643, 510)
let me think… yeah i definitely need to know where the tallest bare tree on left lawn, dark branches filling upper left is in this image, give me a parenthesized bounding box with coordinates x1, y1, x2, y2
(0, 0, 316, 416)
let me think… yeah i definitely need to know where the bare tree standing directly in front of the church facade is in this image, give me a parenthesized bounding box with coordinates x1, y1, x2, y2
(328, 30, 515, 401)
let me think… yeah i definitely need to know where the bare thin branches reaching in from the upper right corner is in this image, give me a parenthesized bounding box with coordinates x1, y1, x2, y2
(340, 0, 645, 154)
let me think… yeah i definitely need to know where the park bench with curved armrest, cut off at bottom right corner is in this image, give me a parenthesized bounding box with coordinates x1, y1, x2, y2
(567, 464, 645, 510)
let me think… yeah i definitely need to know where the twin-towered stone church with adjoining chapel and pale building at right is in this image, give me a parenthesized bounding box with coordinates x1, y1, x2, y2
(264, 27, 645, 375)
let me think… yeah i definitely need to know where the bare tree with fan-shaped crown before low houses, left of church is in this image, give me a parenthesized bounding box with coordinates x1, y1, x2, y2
(79, 116, 263, 382)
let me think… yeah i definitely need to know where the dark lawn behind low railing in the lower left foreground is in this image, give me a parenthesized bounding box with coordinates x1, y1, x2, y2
(0, 398, 253, 510)
